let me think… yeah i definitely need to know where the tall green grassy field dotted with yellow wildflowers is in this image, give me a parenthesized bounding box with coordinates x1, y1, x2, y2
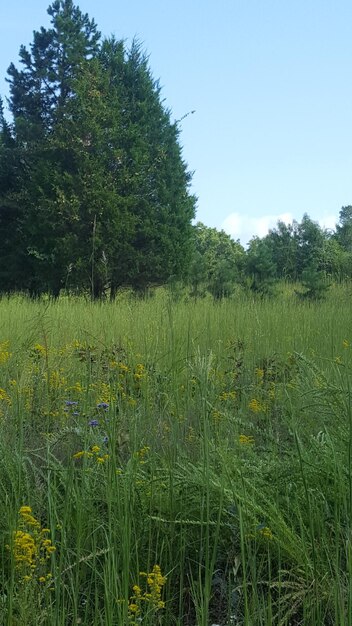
(0, 286, 352, 626)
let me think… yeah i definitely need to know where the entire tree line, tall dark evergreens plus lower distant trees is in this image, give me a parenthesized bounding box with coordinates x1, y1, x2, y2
(0, 0, 352, 299)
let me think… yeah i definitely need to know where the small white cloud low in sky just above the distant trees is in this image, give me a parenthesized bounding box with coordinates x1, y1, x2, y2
(221, 212, 293, 245)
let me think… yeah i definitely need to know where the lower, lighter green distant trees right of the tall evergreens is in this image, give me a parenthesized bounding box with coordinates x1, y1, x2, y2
(189, 206, 352, 299)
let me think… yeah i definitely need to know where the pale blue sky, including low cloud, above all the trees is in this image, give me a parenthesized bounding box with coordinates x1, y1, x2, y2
(0, 0, 352, 245)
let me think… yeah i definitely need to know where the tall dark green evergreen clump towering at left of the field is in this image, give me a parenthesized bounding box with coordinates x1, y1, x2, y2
(0, 0, 195, 298)
